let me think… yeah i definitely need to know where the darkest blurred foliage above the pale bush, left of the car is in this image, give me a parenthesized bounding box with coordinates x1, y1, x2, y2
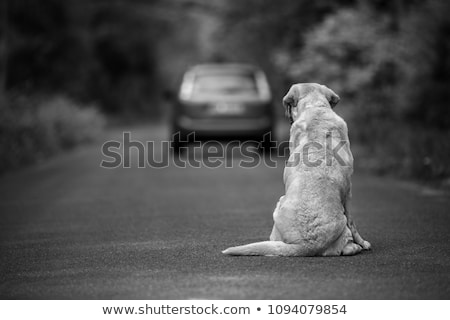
(0, 0, 165, 115)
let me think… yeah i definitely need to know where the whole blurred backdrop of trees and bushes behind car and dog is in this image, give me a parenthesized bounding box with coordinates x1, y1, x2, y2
(0, 0, 450, 184)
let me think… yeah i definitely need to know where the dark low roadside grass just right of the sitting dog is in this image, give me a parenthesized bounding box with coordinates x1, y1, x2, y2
(351, 121, 450, 183)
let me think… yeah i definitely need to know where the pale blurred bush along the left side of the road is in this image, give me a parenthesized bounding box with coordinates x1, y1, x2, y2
(0, 96, 105, 172)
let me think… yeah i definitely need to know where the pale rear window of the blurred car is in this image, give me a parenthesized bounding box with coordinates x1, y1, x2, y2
(192, 73, 258, 98)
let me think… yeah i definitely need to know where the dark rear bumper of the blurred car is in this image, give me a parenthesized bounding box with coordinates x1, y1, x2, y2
(174, 116, 273, 137)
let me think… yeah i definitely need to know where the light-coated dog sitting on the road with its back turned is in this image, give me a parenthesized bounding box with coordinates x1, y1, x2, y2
(222, 83, 371, 256)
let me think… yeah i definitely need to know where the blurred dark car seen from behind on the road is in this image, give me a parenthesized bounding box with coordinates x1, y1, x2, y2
(171, 64, 275, 152)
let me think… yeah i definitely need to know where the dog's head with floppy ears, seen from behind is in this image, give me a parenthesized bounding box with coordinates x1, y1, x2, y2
(283, 83, 340, 124)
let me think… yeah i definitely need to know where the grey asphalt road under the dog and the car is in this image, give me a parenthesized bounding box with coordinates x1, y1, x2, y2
(0, 126, 450, 299)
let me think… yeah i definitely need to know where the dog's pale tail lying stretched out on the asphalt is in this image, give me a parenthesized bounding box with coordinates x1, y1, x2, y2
(222, 241, 317, 257)
